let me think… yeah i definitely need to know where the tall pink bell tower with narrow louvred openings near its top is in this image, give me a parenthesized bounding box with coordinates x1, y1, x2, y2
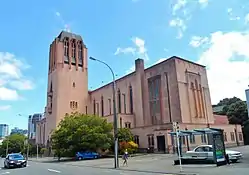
(45, 31, 88, 144)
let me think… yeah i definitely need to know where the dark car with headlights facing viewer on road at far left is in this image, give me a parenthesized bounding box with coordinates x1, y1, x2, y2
(4, 153, 27, 168)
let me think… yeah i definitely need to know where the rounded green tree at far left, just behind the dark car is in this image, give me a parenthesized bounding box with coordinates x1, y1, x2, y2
(2, 134, 27, 153)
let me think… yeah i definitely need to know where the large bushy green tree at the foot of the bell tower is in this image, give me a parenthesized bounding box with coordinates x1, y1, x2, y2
(51, 113, 113, 158)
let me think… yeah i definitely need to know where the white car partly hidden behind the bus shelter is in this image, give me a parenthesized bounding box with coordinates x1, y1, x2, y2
(186, 145, 242, 163)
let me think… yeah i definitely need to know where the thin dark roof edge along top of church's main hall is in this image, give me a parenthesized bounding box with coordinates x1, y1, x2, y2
(89, 56, 206, 94)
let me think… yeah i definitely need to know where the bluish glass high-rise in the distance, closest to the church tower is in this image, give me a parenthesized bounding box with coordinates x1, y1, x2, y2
(28, 114, 42, 139)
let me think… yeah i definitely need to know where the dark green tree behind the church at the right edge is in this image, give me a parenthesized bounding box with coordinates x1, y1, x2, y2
(226, 101, 248, 125)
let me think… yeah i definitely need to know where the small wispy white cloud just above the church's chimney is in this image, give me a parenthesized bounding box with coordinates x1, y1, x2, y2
(114, 37, 149, 60)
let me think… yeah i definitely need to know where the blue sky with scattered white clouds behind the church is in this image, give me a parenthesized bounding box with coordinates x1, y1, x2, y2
(0, 0, 249, 128)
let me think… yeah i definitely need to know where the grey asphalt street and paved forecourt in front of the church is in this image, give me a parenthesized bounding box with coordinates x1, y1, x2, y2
(0, 146, 249, 175)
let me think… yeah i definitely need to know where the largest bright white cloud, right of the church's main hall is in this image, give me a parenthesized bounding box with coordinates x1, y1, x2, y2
(193, 31, 249, 104)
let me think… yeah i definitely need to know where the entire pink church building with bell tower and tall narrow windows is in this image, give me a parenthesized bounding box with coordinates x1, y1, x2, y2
(36, 31, 243, 152)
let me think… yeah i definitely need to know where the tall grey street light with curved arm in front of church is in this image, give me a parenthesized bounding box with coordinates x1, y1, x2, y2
(89, 57, 119, 168)
